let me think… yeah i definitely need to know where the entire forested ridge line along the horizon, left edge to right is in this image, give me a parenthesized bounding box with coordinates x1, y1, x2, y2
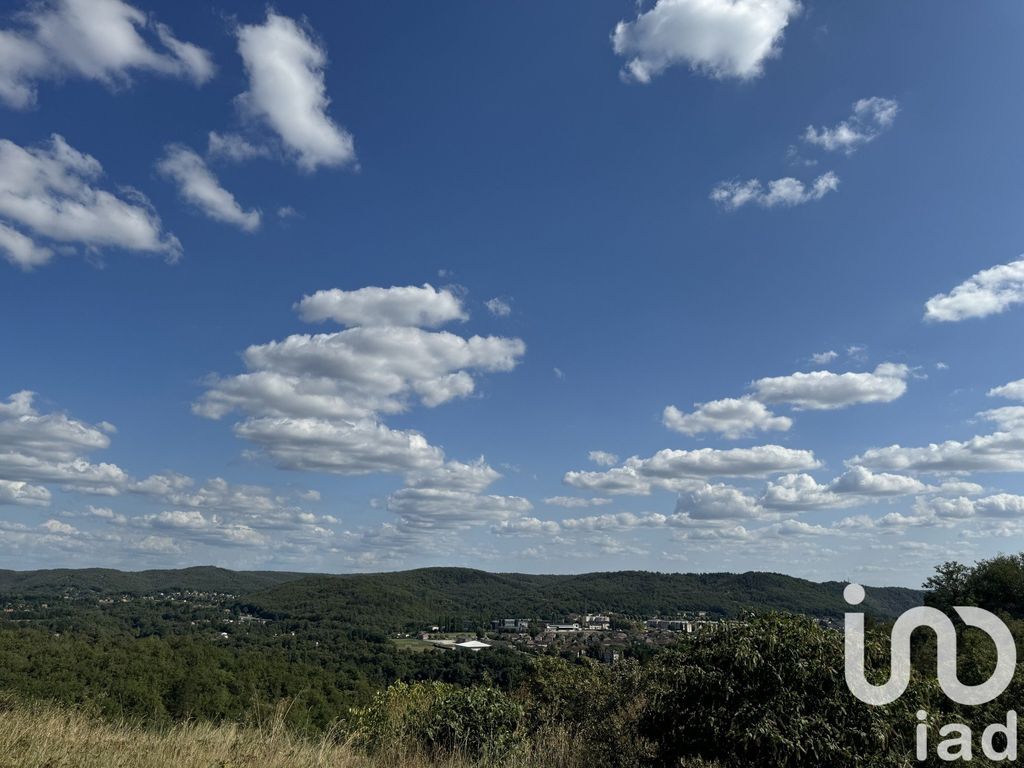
(0, 566, 923, 632)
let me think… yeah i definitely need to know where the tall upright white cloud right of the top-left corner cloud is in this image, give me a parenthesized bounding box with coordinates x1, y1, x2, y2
(238, 11, 355, 171)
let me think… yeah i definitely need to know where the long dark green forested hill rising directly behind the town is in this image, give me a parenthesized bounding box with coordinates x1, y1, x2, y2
(239, 568, 923, 631)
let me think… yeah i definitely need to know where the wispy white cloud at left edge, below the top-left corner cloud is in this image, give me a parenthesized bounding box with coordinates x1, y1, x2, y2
(0, 134, 181, 268)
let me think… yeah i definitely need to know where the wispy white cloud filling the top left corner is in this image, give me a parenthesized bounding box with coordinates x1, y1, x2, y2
(0, 0, 214, 109)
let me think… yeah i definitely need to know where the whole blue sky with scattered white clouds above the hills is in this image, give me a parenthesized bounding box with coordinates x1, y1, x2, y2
(0, 0, 1024, 586)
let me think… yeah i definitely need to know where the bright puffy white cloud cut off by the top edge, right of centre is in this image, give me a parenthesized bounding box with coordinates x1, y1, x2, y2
(611, 0, 800, 83)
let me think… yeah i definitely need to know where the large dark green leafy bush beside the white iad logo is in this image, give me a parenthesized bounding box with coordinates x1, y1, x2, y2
(640, 614, 920, 768)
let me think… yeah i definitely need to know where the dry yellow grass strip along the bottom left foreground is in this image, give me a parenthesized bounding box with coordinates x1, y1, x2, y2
(0, 701, 579, 768)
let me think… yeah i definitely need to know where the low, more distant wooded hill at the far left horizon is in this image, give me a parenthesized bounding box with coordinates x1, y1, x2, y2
(0, 565, 309, 598)
